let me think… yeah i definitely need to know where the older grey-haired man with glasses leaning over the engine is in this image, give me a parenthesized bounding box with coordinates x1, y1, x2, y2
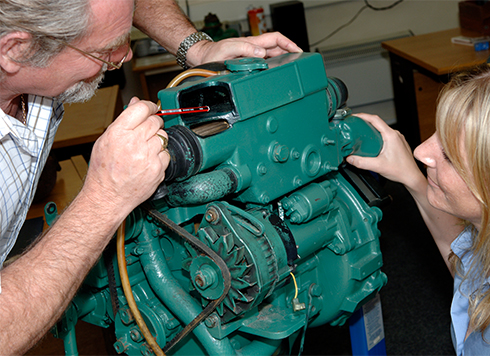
(0, 0, 299, 355)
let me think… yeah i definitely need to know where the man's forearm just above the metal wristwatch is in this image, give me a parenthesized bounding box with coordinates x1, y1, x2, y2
(134, 0, 196, 54)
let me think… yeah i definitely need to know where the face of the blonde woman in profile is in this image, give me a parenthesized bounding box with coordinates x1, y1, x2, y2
(414, 132, 481, 229)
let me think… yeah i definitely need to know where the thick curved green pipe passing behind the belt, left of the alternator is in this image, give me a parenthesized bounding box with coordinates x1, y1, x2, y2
(139, 232, 236, 355)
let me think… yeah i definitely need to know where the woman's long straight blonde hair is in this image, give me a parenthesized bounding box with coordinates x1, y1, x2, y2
(436, 64, 490, 332)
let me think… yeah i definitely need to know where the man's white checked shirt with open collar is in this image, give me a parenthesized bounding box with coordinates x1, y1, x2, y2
(0, 95, 64, 266)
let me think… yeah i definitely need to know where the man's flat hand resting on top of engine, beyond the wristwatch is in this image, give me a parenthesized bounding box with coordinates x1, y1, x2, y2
(187, 32, 303, 66)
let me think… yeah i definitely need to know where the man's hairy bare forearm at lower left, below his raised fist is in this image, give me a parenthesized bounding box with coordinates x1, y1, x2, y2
(0, 188, 123, 355)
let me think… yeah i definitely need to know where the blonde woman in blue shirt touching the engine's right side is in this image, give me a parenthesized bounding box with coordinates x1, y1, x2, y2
(347, 64, 490, 355)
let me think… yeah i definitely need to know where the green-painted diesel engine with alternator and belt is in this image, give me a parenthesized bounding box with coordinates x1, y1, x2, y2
(55, 53, 387, 355)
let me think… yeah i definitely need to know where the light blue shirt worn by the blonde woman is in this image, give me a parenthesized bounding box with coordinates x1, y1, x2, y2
(451, 227, 490, 356)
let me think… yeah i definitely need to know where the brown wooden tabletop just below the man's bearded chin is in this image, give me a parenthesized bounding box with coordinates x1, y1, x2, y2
(53, 85, 122, 149)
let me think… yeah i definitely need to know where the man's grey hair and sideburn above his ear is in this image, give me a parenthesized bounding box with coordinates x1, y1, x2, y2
(0, 0, 90, 67)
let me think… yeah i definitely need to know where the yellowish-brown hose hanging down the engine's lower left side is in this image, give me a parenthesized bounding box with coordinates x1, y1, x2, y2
(117, 221, 165, 356)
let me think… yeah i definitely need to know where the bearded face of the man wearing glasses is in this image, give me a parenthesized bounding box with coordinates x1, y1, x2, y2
(24, 0, 134, 103)
